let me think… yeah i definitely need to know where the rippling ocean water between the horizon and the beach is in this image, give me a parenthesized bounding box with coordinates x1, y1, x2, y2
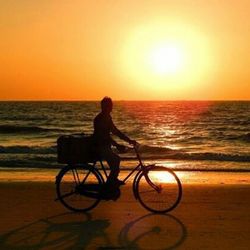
(0, 101, 250, 171)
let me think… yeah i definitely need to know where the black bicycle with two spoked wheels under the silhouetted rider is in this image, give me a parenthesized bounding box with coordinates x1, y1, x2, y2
(56, 145, 182, 213)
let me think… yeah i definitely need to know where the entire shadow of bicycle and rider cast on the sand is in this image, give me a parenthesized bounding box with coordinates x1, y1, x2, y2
(0, 213, 187, 250)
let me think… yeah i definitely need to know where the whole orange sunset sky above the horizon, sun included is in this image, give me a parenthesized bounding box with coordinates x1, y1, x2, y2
(0, 0, 250, 100)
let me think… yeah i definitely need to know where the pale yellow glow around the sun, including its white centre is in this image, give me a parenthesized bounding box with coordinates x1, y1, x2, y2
(121, 20, 214, 95)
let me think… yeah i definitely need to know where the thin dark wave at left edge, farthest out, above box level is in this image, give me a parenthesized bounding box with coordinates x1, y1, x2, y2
(0, 125, 65, 134)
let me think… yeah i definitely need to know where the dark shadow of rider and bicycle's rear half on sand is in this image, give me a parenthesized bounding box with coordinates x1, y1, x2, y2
(0, 213, 110, 250)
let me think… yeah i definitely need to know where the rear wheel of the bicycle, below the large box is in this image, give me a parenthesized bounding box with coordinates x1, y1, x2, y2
(56, 164, 103, 212)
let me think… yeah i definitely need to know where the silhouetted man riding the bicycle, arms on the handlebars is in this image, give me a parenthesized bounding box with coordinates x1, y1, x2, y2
(94, 97, 136, 185)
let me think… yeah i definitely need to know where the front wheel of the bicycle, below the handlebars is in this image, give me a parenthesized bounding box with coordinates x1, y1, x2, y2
(135, 165, 182, 213)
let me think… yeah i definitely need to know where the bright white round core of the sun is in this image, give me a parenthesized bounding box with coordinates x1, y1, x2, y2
(148, 44, 184, 75)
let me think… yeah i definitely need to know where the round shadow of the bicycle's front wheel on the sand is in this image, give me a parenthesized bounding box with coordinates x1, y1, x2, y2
(118, 214, 187, 250)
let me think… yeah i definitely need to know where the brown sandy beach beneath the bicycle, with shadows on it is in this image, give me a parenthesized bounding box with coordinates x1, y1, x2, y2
(0, 173, 250, 249)
